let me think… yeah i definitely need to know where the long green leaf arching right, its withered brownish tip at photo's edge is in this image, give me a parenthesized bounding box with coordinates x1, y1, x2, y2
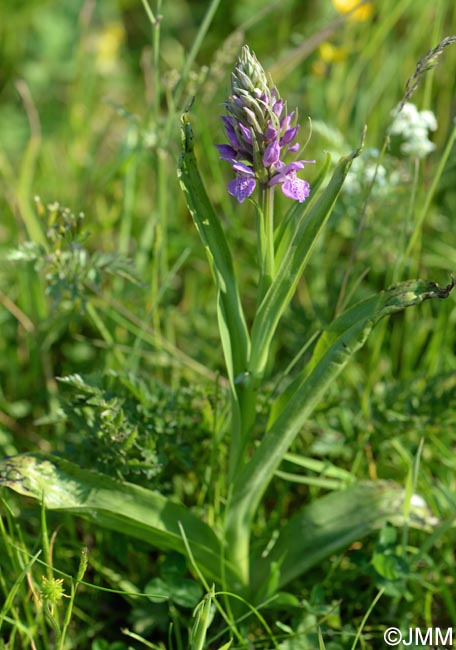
(227, 280, 454, 580)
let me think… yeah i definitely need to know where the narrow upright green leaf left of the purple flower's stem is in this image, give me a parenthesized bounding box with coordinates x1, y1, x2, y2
(178, 113, 249, 386)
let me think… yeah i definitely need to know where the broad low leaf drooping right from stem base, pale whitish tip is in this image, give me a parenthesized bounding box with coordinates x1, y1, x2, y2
(250, 481, 435, 599)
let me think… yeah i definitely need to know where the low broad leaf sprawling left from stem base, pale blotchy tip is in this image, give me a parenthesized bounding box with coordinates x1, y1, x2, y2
(0, 454, 235, 582)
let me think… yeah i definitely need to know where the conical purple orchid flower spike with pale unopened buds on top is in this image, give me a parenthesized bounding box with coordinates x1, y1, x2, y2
(216, 45, 315, 203)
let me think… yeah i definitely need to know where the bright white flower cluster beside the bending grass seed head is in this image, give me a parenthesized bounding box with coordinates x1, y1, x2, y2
(390, 103, 437, 158)
